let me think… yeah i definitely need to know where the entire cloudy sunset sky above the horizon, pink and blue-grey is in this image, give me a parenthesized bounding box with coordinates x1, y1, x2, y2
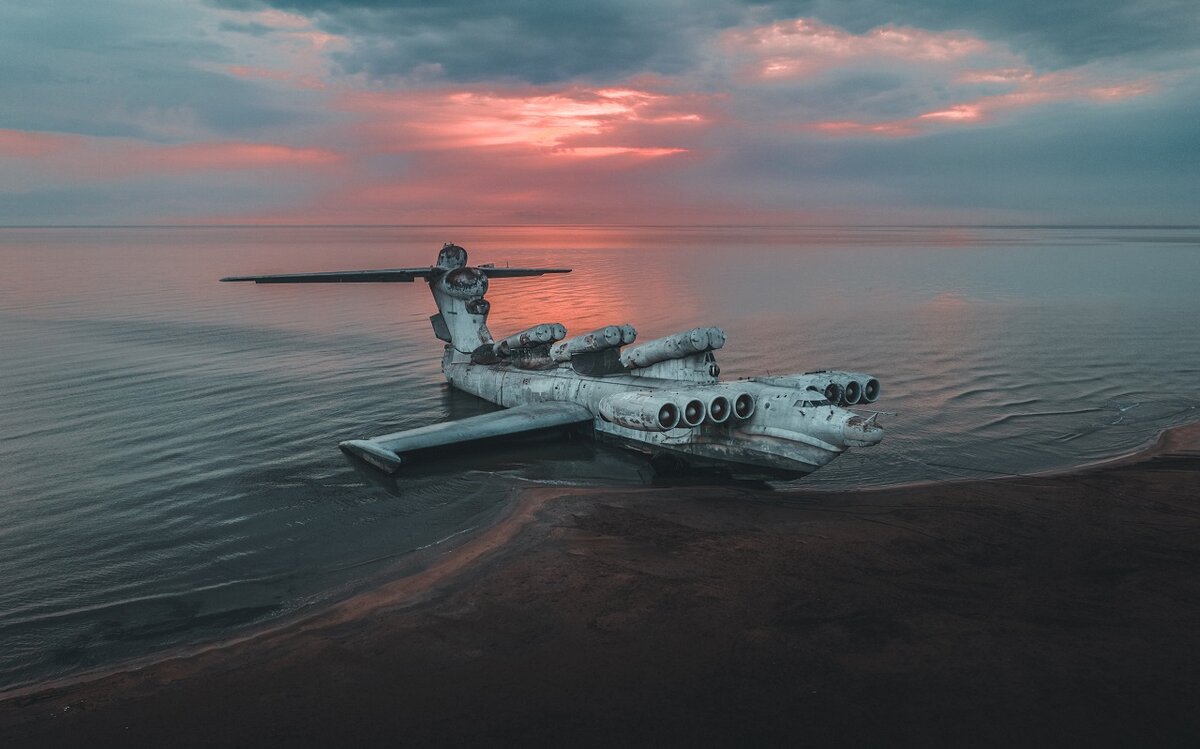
(0, 0, 1200, 226)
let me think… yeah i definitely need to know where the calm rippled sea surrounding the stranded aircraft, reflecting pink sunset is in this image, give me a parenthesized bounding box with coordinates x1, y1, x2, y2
(0, 227, 1200, 687)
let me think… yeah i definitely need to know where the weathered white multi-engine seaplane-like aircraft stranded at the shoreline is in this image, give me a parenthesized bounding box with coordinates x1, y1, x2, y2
(222, 244, 883, 479)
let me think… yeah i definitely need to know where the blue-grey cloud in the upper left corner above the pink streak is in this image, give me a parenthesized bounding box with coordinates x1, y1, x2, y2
(0, 0, 320, 142)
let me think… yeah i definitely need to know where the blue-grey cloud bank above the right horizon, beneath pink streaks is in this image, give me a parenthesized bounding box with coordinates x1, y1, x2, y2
(689, 85, 1200, 223)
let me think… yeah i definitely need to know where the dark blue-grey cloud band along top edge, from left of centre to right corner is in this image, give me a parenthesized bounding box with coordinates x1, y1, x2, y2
(216, 0, 1200, 84)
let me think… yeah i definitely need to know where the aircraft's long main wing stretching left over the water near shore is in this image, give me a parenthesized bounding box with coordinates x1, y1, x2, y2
(338, 401, 594, 473)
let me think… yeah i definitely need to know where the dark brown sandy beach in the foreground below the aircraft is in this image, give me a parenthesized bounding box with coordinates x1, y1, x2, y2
(0, 425, 1200, 748)
